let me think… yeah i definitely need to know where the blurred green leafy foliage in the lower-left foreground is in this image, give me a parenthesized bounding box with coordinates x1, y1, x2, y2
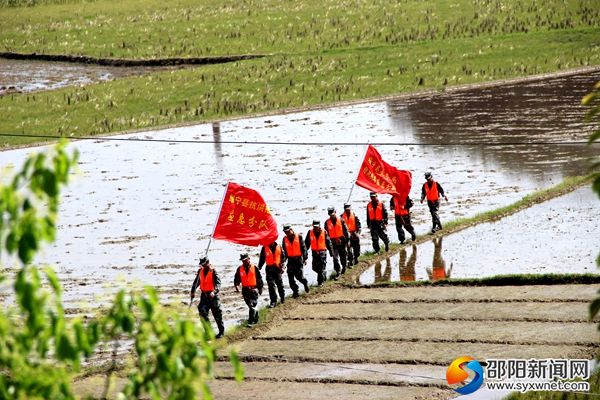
(0, 143, 241, 399)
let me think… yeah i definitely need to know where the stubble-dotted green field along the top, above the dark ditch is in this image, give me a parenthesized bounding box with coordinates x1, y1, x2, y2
(0, 0, 600, 58)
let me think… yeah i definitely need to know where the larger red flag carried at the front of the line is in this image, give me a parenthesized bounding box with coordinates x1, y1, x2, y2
(213, 182, 279, 246)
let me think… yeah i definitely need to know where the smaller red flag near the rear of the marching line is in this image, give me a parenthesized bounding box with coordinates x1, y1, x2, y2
(356, 145, 412, 199)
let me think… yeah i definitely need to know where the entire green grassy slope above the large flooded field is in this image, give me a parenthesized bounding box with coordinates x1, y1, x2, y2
(0, 0, 600, 146)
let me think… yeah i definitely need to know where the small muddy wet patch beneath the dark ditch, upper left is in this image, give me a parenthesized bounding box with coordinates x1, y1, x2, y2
(0, 58, 166, 96)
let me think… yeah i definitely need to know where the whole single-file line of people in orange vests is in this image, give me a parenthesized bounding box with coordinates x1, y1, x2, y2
(190, 172, 448, 338)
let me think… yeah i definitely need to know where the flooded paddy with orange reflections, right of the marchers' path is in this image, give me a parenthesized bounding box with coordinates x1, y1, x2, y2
(360, 187, 600, 284)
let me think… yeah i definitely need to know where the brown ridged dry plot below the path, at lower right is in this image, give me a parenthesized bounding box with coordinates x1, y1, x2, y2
(205, 285, 598, 400)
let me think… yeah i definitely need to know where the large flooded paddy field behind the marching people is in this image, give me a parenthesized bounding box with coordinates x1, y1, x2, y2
(0, 72, 600, 322)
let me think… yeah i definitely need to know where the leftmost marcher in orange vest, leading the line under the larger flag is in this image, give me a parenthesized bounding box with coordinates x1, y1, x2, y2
(190, 257, 225, 339)
